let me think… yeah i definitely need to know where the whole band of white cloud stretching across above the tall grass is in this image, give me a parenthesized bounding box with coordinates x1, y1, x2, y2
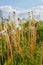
(0, 6, 43, 19)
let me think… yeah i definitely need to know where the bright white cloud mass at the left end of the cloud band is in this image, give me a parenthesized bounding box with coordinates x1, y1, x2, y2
(0, 6, 16, 17)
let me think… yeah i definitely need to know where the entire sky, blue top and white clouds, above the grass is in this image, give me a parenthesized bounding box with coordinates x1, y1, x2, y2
(0, 0, 43, 19)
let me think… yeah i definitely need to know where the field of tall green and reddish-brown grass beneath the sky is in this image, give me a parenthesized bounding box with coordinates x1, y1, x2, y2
(0, 11, 43, 65)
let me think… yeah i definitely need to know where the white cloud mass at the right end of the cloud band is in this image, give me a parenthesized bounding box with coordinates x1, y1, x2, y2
(32, 6, 43, 20)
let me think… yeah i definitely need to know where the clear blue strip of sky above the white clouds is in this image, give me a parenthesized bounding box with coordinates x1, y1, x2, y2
(0, 0, 43, 9)
